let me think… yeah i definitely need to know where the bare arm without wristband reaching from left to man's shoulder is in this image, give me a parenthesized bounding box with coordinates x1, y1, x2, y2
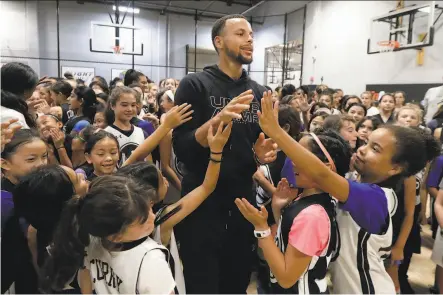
(123, 104, 193, 166)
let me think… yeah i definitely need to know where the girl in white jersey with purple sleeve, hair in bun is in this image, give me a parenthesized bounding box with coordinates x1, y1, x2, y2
(245, 92, 440, 294)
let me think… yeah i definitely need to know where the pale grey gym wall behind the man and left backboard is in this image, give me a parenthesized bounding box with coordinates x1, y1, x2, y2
(0, 1, 307, 84)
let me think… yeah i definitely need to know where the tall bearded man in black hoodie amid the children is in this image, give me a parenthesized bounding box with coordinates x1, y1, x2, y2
(173, 15, 276, 294)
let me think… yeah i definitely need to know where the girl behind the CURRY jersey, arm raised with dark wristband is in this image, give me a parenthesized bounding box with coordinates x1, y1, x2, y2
(117, 123, 232, 294)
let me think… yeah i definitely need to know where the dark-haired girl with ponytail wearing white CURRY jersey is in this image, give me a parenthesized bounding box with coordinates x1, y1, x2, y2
(41, 175, 175, 294)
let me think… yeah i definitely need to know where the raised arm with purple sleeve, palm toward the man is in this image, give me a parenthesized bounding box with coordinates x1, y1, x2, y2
(258, 92, 388, 233)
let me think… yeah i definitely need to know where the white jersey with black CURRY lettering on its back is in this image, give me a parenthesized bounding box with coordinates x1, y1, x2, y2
(85, 237, 175, 294)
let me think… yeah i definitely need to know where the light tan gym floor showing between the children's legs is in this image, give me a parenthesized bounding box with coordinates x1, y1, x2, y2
(247, 225, 435, 294)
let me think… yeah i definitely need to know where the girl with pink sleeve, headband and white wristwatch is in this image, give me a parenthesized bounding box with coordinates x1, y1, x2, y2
(236, 130, 351, 294)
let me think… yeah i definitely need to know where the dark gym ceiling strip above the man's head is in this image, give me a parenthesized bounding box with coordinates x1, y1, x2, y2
(77, 0, 310, 17)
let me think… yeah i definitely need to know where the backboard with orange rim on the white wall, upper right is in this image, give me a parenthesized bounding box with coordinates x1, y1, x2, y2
(367, 1, 443, 54)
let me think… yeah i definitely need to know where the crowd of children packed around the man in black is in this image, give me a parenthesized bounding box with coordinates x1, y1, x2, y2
(1, 17, 443, 294)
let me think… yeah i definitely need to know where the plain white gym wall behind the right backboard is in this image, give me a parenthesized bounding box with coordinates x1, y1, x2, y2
(303, 1, 443, 96)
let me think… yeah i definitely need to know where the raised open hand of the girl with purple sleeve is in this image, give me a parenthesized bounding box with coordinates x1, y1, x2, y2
(257, 91, 280, 137)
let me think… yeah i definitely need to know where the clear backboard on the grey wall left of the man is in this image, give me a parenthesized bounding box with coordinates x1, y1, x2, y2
(89, 21, 143, 55)
